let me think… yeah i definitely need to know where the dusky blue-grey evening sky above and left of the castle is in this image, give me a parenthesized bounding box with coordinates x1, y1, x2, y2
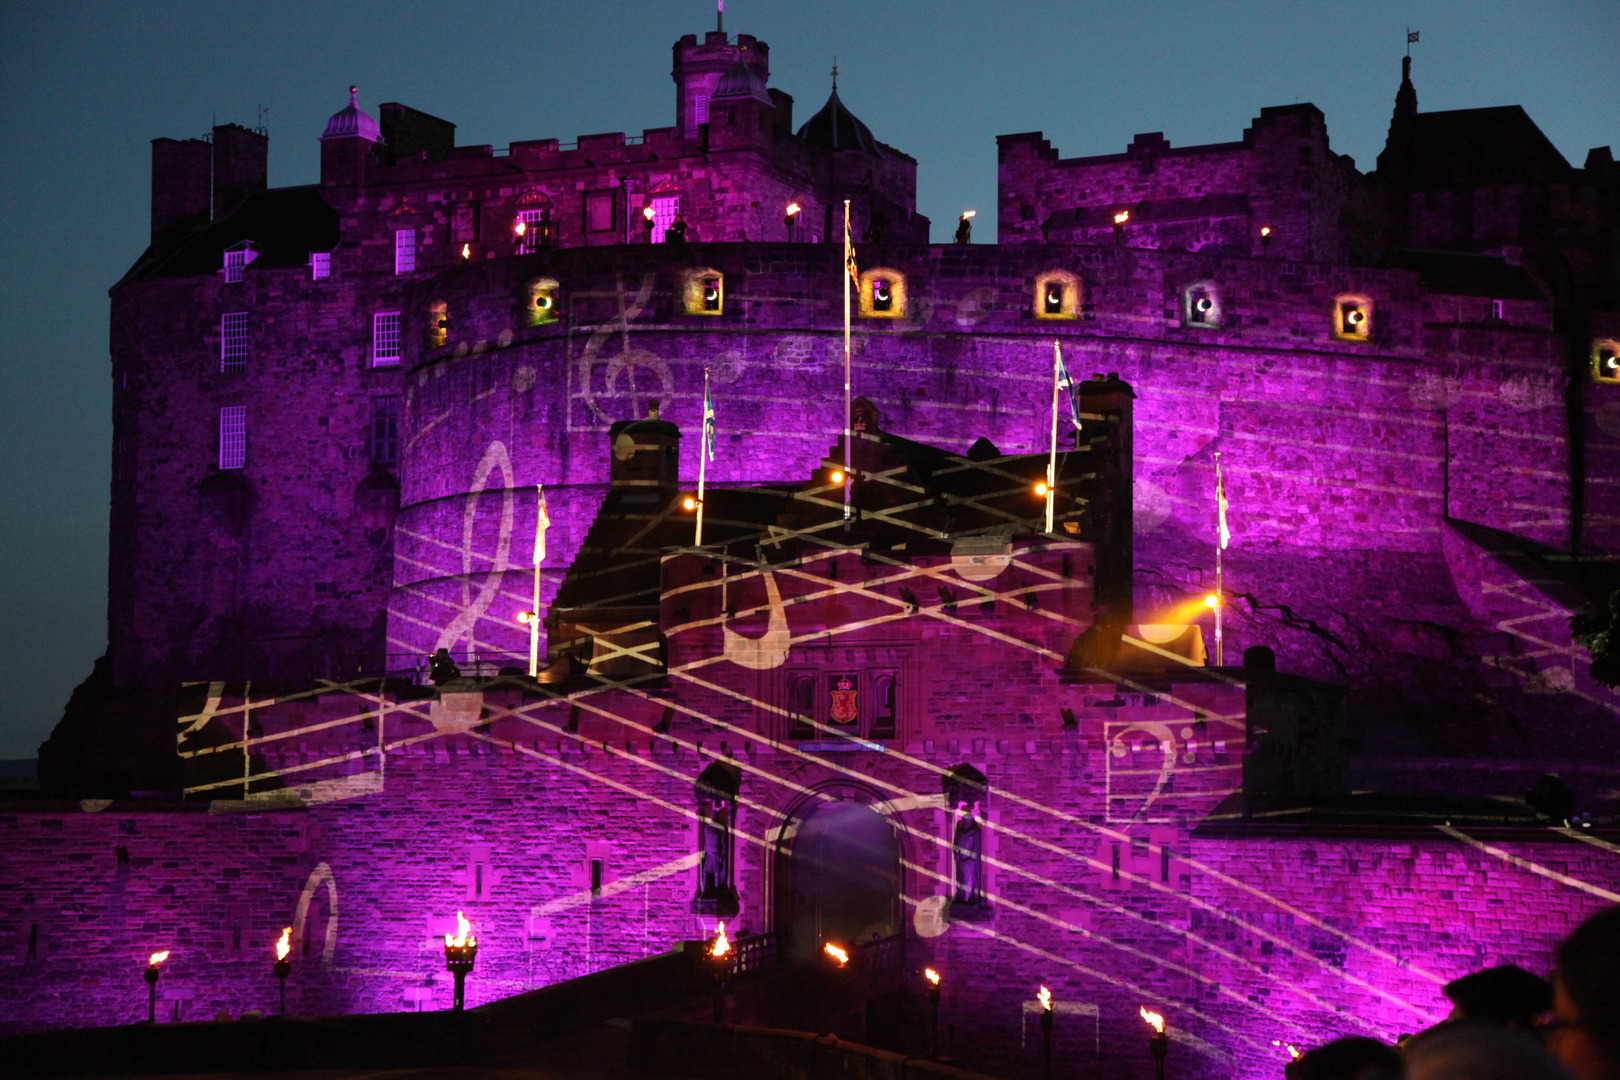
(0, 0, 1620, 758)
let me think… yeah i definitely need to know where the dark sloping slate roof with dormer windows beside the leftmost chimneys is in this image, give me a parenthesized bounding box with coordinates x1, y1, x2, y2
(123, 185, 337, 282)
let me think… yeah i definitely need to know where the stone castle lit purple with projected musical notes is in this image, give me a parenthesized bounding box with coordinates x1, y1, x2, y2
(12, 19, 1620, 1077)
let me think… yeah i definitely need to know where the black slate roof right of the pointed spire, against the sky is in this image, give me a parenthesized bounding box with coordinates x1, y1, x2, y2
(1411, 105, 1570, 188)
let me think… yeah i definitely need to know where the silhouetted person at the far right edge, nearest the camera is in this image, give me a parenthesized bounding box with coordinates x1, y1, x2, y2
(1545, 907, 1620, 1080)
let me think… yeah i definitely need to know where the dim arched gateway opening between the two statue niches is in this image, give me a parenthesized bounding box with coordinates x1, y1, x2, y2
(776, 800, 902, 959)
